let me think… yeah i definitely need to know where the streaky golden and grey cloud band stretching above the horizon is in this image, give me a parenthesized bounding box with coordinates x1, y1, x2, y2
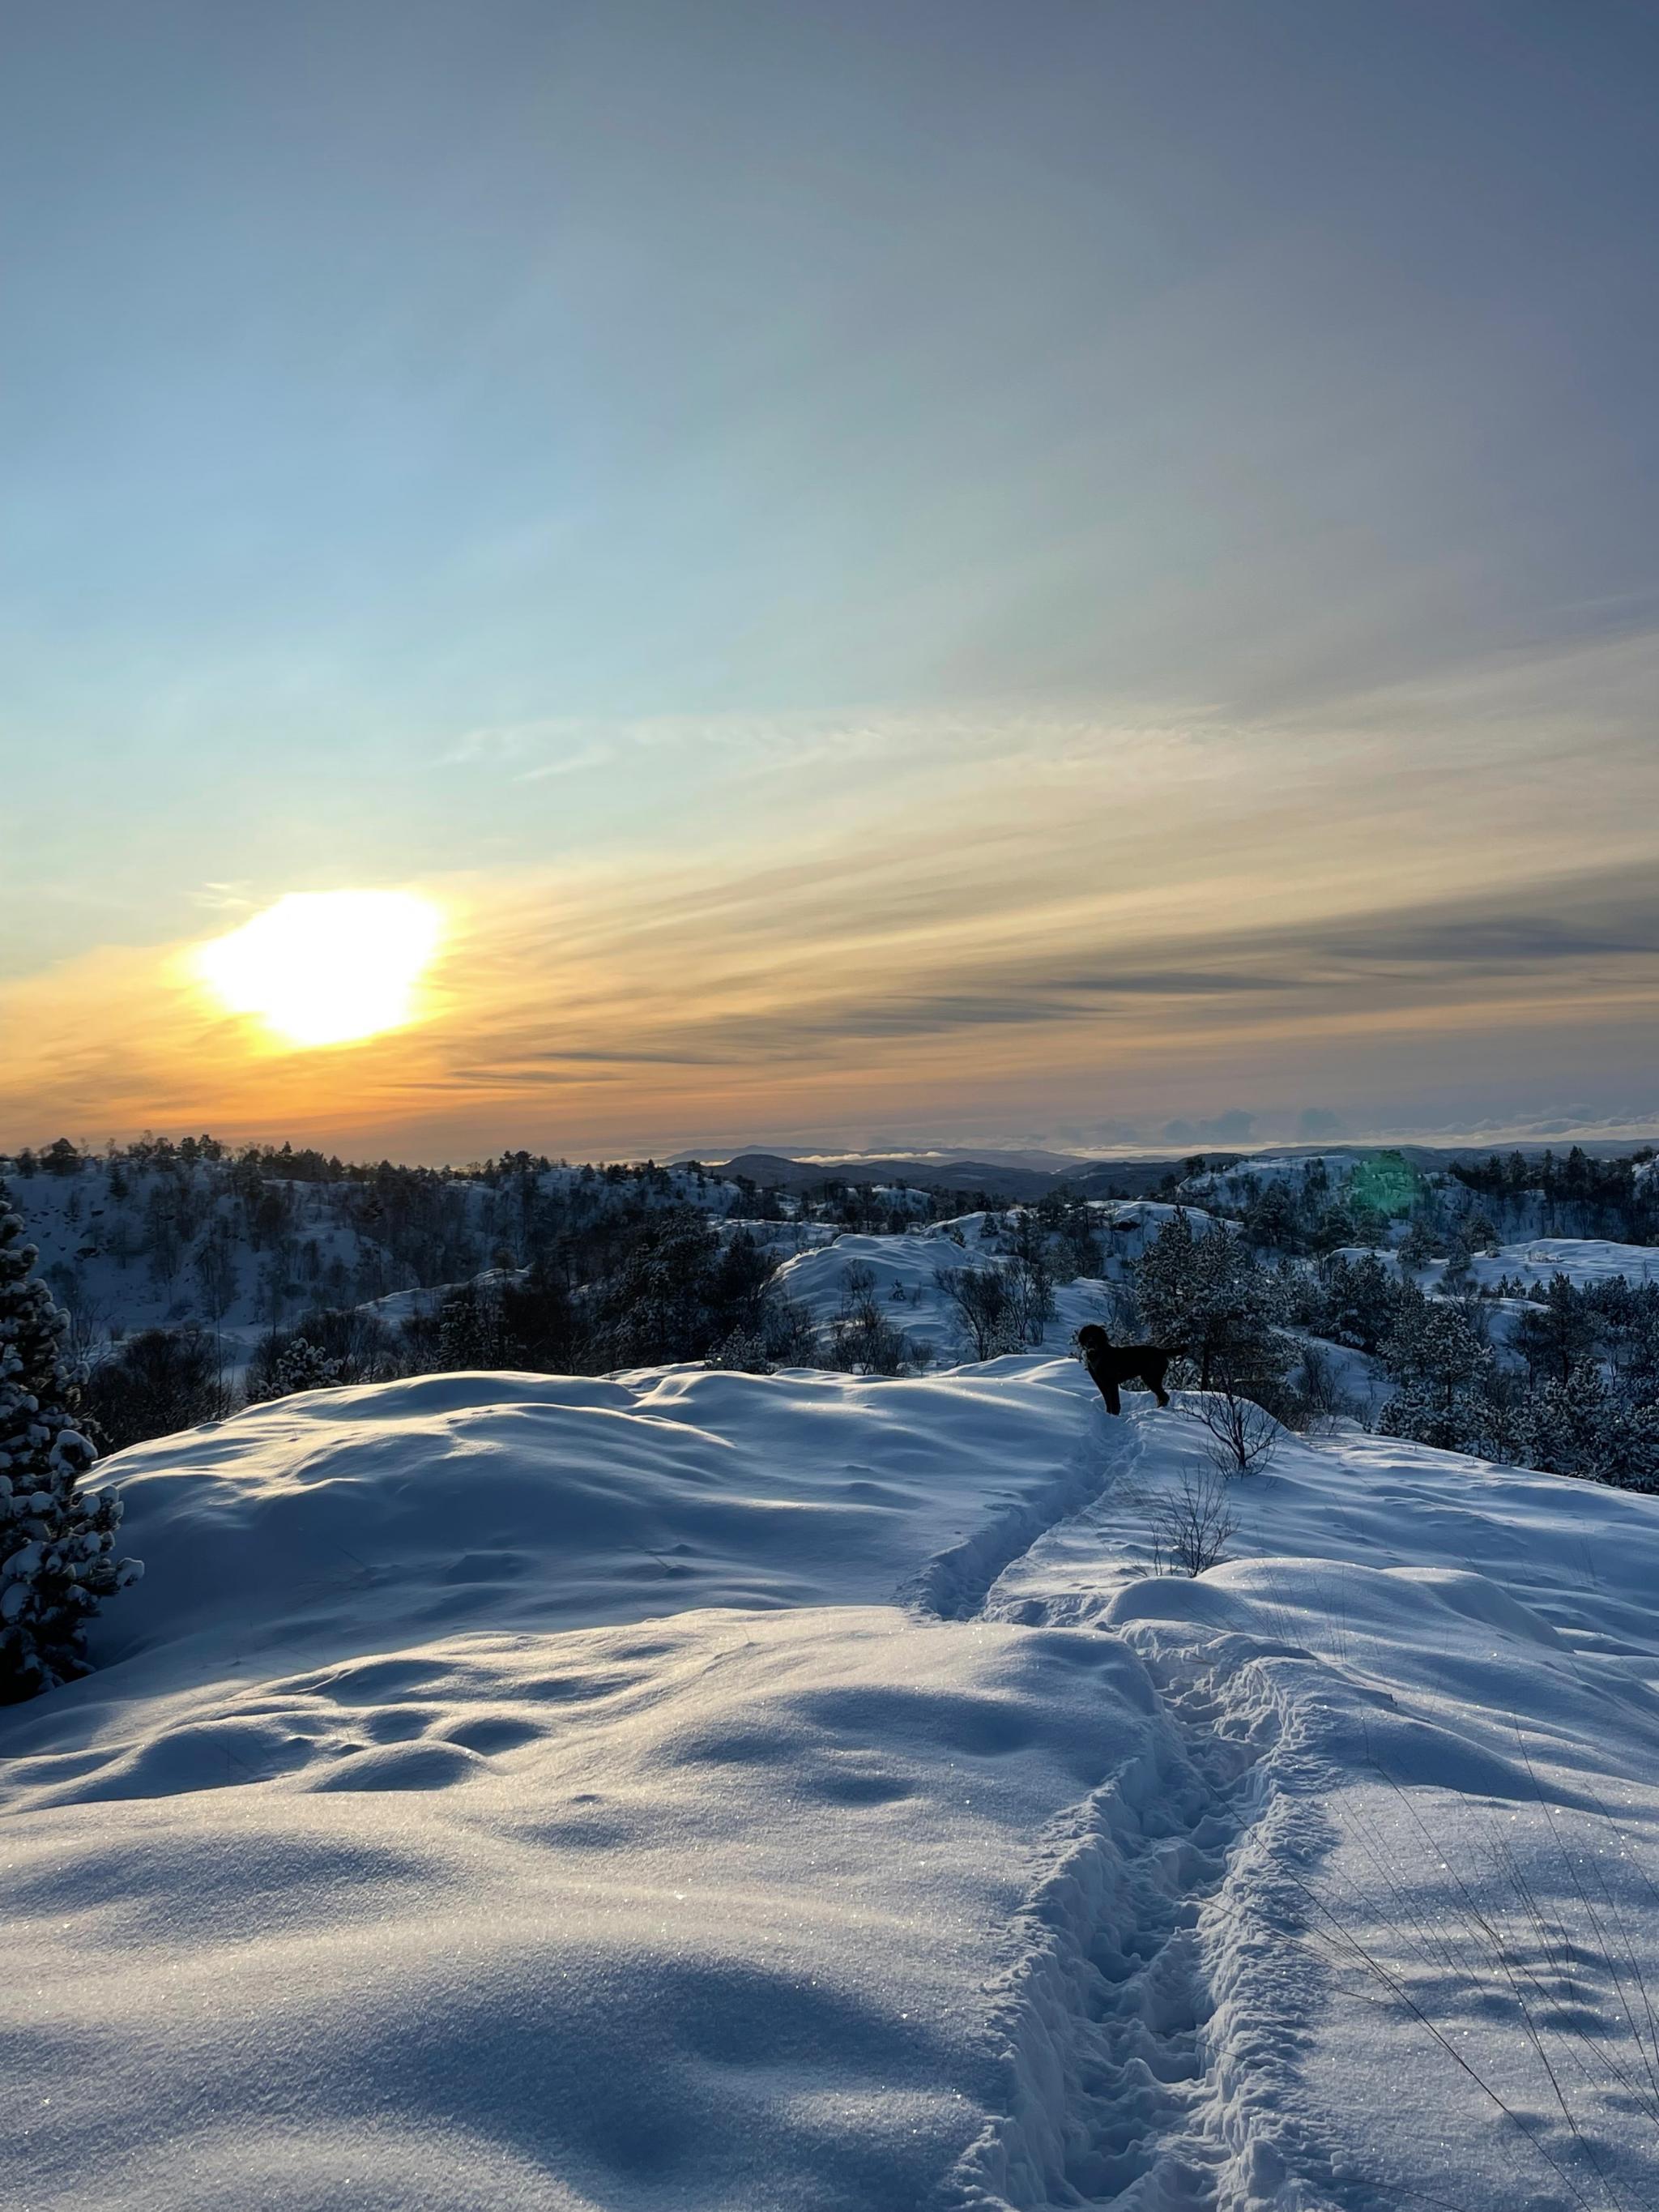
(0, 637, 1659, 1152)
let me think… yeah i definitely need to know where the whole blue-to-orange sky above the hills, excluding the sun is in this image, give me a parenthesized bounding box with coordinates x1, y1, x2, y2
(0, 0, 1659, 1159)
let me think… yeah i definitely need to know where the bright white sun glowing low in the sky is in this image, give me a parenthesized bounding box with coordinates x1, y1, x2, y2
(194, 891, 442, 1046)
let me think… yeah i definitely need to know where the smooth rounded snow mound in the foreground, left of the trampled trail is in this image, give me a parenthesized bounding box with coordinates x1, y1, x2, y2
(0, 1608, 1185, 2212)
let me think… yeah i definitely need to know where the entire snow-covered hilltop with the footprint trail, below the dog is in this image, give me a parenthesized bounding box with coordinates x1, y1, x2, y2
(0, 1356, 1659, 2212)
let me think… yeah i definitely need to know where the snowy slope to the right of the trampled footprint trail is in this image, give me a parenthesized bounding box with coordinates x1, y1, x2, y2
(984, 1413, 1659, 2212)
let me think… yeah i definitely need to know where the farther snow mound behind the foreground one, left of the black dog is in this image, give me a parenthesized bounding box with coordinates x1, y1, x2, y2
(75, 1358, 1099, 1694)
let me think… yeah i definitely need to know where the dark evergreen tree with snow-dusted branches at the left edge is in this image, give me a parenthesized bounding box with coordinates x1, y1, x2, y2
(0, 1184, 143, 1706)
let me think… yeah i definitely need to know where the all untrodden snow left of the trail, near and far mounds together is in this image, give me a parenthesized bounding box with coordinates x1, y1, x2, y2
(0, 1360, 1172, 2212)
